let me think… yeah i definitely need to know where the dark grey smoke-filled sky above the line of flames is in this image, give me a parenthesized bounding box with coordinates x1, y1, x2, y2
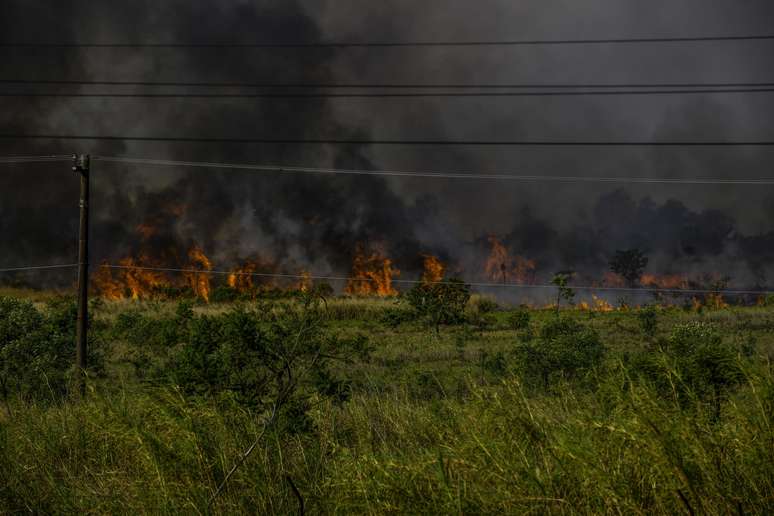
(0, 0, 774, 287)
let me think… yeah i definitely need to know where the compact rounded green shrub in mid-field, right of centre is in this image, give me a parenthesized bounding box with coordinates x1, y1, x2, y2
(516, 319, 606, 387)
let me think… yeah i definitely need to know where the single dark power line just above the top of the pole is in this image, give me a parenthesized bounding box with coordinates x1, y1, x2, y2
(0, 134, 774, 147)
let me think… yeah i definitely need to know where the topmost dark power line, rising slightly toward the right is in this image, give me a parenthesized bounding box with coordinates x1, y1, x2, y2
(0, 34, 774, 49)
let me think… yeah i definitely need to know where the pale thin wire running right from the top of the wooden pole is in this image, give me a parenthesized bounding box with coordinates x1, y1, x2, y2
(91, 156, 774, 186)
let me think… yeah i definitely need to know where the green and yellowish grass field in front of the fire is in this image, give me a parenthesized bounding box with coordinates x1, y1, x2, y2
(0, 292, 774, 514)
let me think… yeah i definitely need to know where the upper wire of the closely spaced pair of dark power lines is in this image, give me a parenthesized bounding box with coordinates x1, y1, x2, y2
(0, 79, 774, 89)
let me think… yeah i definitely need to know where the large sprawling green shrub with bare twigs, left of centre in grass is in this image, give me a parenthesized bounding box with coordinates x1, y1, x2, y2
(170, 298, 369, 424)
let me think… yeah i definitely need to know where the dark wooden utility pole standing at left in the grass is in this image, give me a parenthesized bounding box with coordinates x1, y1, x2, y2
(73, 154, 90, 378)
